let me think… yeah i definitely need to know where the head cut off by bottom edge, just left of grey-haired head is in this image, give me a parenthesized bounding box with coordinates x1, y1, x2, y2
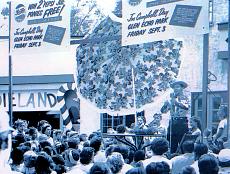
(89, 162, 112, 174)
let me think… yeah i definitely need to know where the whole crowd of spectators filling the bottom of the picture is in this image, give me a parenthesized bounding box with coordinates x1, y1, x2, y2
(0, 108, 230, 174)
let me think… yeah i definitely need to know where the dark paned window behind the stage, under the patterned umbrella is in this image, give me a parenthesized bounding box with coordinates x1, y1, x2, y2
(101, 111, 144, 133)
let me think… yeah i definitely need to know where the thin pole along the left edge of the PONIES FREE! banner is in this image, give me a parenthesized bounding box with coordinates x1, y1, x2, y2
(8, 2, 13, 126)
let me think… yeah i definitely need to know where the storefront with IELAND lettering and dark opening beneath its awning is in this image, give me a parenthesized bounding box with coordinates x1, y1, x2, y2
(0, 74, 74, 129)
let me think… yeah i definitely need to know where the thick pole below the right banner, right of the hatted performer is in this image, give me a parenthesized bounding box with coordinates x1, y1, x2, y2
(201, 34, 209, 142)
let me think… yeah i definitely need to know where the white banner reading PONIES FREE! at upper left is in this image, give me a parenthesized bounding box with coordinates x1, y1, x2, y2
(11, 0, 70, 54)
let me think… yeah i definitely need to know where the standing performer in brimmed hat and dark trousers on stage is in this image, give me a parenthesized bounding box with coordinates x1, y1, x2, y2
(161, 81, 189, 153)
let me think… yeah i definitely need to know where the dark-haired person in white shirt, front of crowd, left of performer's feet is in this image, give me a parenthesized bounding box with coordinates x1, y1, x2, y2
(143, 138, 172, 169)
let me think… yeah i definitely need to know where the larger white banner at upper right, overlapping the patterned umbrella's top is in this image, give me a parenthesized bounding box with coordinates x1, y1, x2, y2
(122, 0, 209, 46)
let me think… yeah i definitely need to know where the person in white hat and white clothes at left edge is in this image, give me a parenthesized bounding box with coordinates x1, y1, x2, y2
(0, 109, 19, 174)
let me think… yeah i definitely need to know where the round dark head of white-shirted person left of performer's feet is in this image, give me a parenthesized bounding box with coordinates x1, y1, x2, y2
(150, 138, 169, 155)
